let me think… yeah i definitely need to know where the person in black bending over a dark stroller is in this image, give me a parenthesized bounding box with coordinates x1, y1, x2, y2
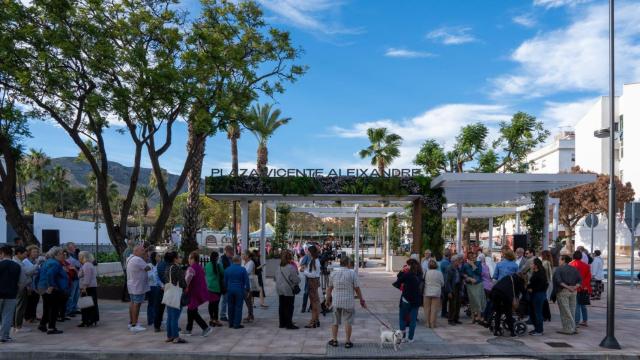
(491, 274, 524, 336)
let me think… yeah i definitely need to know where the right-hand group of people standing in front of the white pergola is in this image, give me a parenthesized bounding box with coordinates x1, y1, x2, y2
(393, 243, 604, 342)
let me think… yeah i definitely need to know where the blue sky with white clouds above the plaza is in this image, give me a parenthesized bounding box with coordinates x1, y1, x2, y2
(26, 0, 640, 175)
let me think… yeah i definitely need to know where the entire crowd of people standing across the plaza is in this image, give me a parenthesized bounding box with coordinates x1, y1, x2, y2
(0, 236, 604, 348)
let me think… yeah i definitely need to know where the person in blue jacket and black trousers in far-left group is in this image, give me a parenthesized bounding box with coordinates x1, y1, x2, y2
(37, 246, 69, 335)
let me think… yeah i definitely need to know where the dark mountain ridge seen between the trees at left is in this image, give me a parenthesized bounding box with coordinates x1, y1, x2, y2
(51, 157, 198, 206)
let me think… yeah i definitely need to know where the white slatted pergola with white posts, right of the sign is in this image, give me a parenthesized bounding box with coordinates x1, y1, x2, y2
(431, 173, 596, 252)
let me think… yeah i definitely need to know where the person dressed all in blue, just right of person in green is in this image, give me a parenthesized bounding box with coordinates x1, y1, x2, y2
(224, 255, 250, 329)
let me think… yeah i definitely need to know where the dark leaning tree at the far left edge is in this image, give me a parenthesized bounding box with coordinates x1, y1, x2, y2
(0, 87, 39, 244)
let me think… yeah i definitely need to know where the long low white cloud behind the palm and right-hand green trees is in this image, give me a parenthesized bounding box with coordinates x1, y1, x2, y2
(331, 104, 511, 167)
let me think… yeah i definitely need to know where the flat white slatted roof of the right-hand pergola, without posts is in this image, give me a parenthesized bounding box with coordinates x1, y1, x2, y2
(431, 173, 597, 205)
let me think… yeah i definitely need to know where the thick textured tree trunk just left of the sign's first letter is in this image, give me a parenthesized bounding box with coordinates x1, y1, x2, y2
(181, 123, 206, 254)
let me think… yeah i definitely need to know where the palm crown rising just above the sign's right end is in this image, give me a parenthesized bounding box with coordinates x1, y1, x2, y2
(360, 128, 402, 177)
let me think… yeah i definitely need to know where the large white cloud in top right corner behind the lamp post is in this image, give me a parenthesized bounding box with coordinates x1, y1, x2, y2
(492, 2, 640, 97)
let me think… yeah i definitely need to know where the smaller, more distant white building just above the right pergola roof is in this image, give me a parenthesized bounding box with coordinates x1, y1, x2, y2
(527, 131, 576, 174)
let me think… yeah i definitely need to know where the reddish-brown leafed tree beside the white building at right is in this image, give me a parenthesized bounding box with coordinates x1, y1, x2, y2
(550, 166, 635, 250)
